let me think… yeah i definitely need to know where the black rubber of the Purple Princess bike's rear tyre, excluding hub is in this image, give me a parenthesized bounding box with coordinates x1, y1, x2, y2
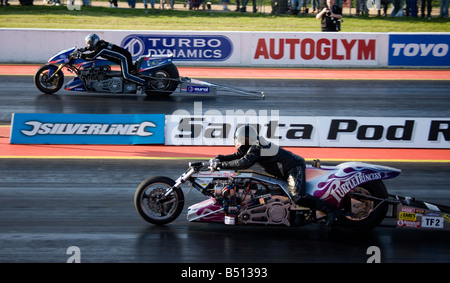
(332, 180, 389, 232)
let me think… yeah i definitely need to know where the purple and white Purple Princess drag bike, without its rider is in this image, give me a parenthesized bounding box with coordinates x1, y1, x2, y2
(134, 161, 401, 232)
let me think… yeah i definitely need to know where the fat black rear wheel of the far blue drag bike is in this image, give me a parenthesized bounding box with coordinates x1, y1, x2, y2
(145, 64, 180, 96)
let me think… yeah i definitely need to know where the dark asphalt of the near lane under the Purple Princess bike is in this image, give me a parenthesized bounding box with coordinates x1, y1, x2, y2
(0, 159, 450, 263)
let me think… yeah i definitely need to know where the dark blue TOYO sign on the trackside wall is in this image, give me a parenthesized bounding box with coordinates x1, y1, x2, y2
(388, 34, 450, 66)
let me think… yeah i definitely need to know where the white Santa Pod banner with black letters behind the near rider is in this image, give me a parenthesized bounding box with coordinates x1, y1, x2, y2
(166, 110, 450, 148)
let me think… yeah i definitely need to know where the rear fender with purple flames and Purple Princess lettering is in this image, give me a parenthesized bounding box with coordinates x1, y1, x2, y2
(306, 162, 401, 206)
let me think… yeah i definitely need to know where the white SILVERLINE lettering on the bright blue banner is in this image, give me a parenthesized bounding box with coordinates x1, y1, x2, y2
(21, 121, 156, 137)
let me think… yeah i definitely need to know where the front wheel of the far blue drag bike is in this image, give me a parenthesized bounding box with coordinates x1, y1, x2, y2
(34, 65, 64, 94)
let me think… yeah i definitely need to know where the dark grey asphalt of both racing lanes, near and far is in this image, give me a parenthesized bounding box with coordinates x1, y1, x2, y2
(0, 67, 450, 262)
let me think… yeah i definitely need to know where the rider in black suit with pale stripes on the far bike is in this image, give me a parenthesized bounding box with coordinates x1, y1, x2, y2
(78, 33, 145, 85)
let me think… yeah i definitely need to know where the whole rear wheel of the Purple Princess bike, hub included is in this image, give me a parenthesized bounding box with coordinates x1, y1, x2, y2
(332, 180, 389, 232)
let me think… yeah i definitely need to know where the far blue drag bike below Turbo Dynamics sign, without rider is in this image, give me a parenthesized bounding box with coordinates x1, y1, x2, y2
(34, 47, 179, 96)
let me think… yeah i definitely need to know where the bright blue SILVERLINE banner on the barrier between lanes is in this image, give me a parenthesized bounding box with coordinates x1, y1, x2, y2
(11, 113, 165, 144)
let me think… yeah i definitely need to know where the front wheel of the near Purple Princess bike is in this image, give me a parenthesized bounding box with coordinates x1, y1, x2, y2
(134, 177, 184, 225)
